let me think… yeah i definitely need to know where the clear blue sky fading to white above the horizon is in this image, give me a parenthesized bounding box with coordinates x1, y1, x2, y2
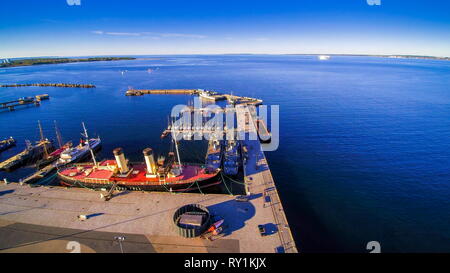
(0, 0, 450, 58)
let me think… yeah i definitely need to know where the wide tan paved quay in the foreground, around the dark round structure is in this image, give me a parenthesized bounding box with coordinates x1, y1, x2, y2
(0, 183, 282, 253)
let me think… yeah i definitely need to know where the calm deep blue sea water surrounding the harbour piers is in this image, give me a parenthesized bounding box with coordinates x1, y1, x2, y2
(0, 55, 450, 252)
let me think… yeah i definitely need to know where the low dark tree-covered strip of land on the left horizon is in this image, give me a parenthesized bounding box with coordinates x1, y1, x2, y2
(0, 57, 136, 67)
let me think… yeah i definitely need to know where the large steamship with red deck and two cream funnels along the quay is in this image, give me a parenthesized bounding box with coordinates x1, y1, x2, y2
(58, 123, 221, 192)
